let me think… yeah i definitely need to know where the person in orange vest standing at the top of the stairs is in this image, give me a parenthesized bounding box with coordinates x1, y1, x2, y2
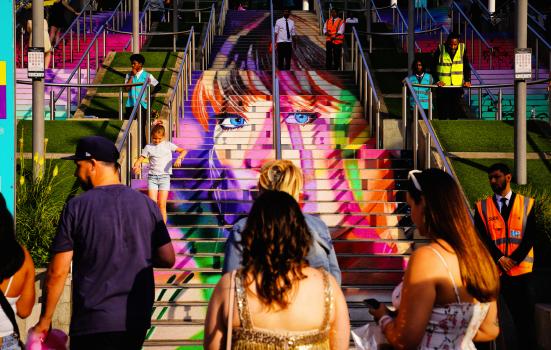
(323, 9, 344, 70)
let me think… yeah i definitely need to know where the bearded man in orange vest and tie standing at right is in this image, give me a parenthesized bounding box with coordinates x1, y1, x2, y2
(475, 163, 535, 349)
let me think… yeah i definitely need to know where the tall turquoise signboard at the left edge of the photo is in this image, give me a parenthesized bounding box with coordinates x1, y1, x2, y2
(0, 0, 15, 214)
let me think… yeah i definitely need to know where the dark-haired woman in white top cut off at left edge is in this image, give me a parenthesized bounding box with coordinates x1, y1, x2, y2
(0, 194, 35, 350)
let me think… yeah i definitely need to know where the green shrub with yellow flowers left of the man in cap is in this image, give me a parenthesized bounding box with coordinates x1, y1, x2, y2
(16, 133, 76, 267)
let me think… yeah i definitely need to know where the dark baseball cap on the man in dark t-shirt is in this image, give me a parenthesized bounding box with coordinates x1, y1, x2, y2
(61, 136, 119, 163)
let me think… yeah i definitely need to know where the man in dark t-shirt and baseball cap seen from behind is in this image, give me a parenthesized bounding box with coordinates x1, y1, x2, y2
(35, 136, 175, 350)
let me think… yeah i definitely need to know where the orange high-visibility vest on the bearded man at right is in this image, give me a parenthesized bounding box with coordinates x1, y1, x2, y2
(476, 194, 534, 276)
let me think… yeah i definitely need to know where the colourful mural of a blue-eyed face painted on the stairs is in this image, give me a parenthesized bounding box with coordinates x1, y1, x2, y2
(138, 6, 417, 349)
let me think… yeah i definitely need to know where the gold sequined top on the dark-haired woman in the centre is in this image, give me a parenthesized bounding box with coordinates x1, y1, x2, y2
(232, 269, 333, 350)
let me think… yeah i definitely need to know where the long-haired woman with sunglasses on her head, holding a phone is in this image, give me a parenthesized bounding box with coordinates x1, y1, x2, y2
(370, 169, 499, 349)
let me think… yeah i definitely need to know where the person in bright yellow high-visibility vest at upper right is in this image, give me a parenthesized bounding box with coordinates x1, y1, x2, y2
(432, 33, 471, 119)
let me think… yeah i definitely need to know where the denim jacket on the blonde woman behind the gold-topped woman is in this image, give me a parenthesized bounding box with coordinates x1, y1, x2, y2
(223, 214, 341, 285)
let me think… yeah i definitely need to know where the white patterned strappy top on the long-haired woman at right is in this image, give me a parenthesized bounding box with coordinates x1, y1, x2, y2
(392, 246, 490, 350)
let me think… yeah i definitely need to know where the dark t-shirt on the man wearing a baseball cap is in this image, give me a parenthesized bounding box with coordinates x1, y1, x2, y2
(52, 185, 170, 335)
